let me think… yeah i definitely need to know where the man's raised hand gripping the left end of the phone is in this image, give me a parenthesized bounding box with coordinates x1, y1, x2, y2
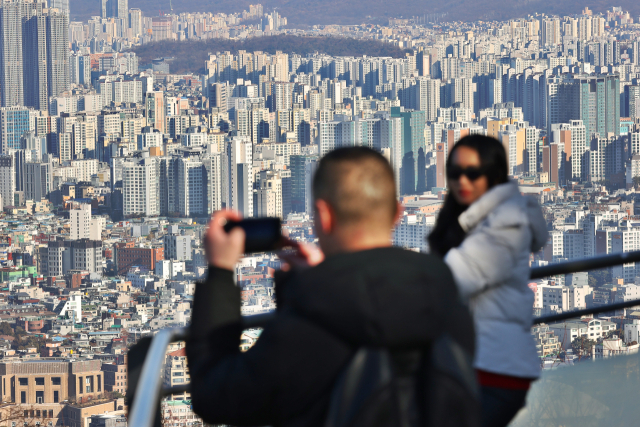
(204, 210, 245, 270)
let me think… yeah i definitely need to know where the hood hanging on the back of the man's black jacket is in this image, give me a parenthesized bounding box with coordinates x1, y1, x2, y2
(276, 247, 473, 353)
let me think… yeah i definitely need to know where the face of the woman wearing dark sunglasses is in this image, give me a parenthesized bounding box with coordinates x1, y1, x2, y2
(447, 147, 489, 206)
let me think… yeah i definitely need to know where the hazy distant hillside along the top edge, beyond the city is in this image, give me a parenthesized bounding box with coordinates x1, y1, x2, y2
(70, 0, 640, 26)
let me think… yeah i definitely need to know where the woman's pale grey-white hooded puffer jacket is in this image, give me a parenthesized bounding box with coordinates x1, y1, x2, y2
(445, 181, 548, 378)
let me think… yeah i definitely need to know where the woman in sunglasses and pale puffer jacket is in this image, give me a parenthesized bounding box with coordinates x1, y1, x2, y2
(428, 135, 548, 427)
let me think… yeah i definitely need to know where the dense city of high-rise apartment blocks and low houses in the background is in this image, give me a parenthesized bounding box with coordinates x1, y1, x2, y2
(0, 0, 640, 427)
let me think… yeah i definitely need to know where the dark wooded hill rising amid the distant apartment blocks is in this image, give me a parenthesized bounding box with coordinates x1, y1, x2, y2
(132, 35, 405, 73)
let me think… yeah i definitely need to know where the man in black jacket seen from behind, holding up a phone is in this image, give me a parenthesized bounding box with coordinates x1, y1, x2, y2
(187, 147, 474, 427)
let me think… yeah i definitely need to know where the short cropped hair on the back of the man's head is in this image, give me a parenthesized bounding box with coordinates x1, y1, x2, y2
(313, 147, 397, 225)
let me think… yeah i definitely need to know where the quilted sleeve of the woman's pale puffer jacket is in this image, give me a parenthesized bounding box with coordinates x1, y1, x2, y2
(445, 212, 532, 301)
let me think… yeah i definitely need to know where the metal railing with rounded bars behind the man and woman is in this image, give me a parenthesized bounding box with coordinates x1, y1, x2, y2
(128, 251, 640, 427)
